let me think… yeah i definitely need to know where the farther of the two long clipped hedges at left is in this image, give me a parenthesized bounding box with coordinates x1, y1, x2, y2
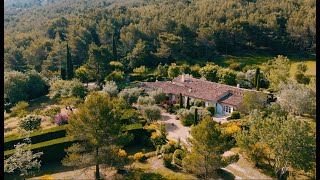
(4, 125, 67, 151)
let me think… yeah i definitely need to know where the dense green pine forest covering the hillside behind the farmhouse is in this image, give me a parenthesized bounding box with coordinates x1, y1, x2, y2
(4, 0, 316, 72)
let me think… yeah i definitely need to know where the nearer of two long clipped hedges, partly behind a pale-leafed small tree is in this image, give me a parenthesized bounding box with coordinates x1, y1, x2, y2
(4, 137, 74, 163)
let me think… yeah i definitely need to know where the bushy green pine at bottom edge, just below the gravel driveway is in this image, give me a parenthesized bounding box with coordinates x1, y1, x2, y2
(182, 116, 232, 179)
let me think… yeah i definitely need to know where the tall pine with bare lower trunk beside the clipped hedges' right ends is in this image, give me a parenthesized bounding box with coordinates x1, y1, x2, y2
(62, 92, 123, 179)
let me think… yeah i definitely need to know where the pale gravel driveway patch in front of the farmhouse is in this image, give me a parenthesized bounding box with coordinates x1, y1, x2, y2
(158, 112, 191, 144)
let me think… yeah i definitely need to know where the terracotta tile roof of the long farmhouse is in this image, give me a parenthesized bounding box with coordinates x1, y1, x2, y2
(143, 75, 260, 106)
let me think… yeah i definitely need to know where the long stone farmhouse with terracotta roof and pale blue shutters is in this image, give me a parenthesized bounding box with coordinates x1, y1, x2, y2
(142, 74, 264, 115)
